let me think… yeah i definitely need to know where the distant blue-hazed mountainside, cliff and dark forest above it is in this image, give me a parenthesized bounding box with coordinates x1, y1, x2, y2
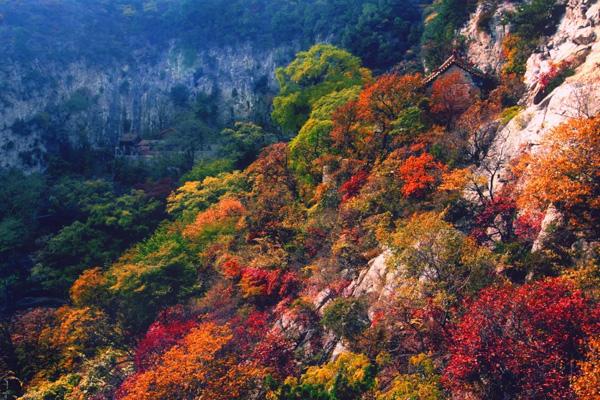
(0, 0, 421, 170)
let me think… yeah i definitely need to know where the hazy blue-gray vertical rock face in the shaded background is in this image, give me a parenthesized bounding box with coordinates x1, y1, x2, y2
(0, 44, 298, 170)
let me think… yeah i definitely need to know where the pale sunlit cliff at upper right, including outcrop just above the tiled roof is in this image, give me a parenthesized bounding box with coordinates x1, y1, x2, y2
(463, 0, 600, 162)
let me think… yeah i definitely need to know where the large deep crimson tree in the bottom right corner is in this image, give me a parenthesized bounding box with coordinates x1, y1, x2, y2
(444, 278, 600, 400)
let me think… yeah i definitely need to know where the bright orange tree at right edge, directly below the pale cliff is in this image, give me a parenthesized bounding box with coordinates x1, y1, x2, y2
(517, 116, 600, 229)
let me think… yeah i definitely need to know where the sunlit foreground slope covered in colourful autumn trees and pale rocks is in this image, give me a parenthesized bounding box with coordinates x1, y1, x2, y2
(0, 0, 600, 400)
